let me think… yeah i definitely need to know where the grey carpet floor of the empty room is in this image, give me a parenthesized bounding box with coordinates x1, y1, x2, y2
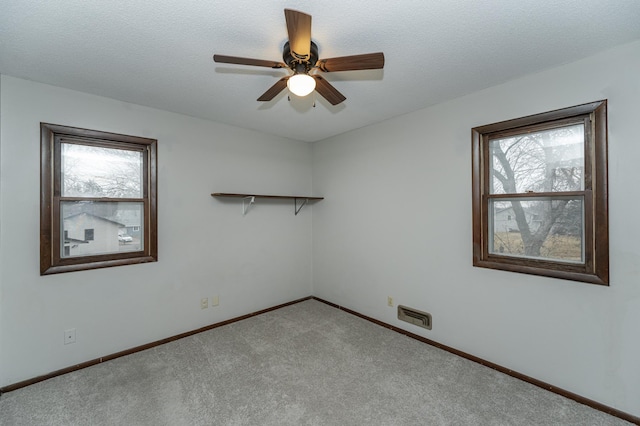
(0, 300, 630, 426)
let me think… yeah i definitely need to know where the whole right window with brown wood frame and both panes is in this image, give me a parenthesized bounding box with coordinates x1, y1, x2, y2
(472, 100, 609, 285)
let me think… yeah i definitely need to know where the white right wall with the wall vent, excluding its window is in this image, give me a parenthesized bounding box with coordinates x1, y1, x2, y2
(313, 42, 640, 416)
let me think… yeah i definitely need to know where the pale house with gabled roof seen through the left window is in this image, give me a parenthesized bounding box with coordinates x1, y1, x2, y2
(61, 213, 124, 257)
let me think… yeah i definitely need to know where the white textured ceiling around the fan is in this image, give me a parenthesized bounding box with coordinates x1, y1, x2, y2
(0, 0, 640, 141)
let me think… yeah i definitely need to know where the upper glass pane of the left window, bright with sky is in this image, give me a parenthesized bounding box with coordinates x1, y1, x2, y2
(61, 143, 143, 198)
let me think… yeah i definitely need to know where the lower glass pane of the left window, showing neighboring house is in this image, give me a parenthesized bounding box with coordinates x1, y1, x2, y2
(60, 201, 144, 258)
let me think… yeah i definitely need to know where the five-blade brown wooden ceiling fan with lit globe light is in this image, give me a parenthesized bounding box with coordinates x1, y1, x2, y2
(213, 9, 384, 105)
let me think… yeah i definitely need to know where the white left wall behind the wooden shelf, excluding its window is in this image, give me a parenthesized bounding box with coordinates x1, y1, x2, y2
(0, 76, 312, 386)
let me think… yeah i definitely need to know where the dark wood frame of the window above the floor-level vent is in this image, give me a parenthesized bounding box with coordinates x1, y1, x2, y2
(471, 100, 609, 285)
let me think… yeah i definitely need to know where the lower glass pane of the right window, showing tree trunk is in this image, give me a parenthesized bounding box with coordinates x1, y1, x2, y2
(489, 198, 584, 263)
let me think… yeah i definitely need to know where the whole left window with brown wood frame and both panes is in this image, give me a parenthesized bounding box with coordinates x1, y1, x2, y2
(40, 123, 158, 275)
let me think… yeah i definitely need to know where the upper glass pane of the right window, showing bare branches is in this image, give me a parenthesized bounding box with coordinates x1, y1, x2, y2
(489, 124, 584, 194)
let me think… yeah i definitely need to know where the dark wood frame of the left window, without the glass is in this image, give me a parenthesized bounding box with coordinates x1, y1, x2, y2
(40, 123, 158, 275)
